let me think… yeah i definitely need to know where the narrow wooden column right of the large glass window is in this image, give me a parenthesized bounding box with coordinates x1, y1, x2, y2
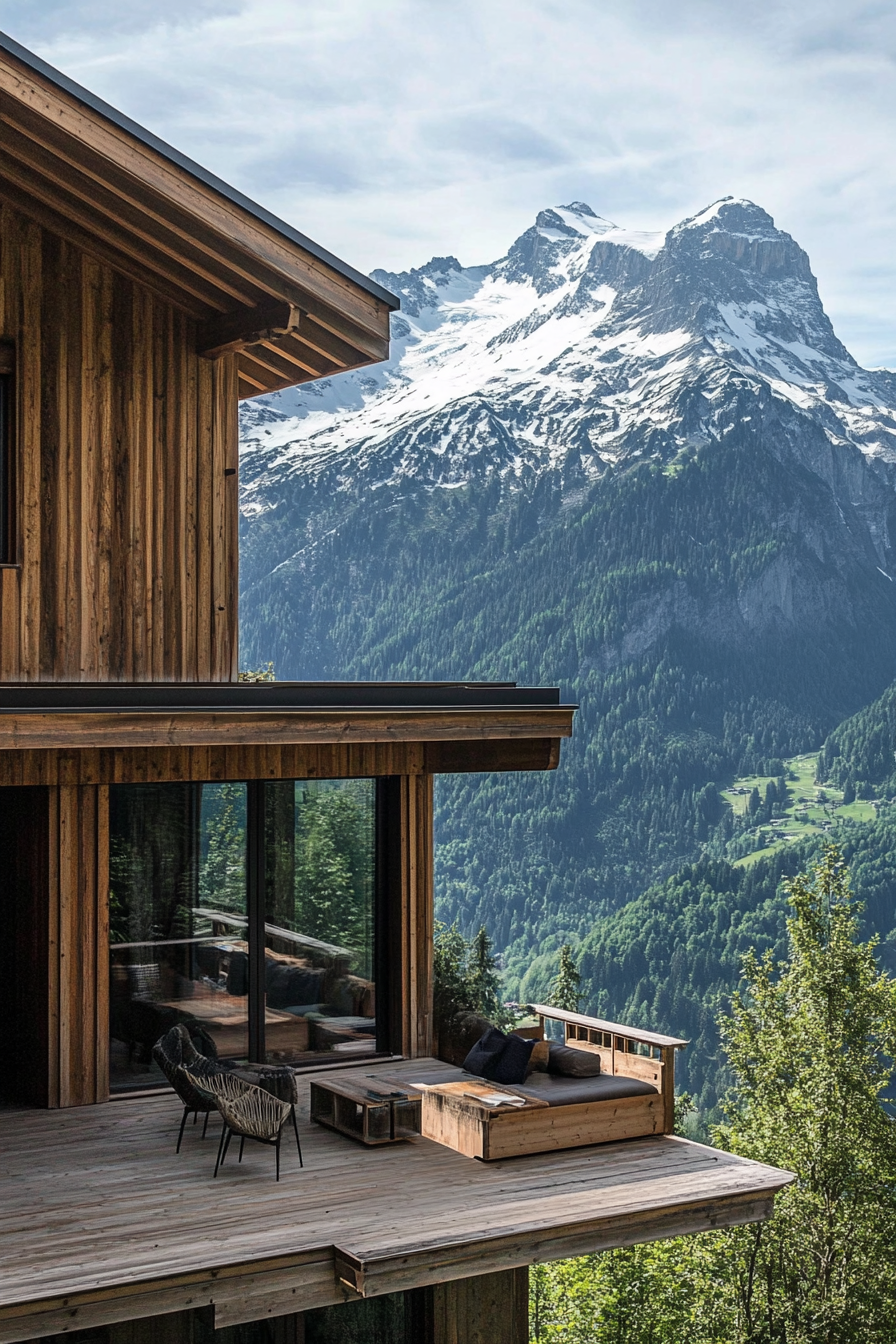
(399, 774, 434, 1059)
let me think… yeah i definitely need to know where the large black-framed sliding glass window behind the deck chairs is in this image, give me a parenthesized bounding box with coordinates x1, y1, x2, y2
(109, 780, 376, 1090)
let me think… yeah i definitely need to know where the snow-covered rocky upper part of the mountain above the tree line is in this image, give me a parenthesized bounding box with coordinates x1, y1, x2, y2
(240, 198, 896, 532)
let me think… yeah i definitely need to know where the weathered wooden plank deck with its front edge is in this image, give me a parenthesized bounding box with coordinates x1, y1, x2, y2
(0, 1064, 790, 1344)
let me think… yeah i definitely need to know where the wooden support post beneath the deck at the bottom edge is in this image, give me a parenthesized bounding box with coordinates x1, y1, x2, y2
(431, 1269, 529, 1344)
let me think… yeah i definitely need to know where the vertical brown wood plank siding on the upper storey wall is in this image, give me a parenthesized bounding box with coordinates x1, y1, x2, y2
(0, 206, 238, 681)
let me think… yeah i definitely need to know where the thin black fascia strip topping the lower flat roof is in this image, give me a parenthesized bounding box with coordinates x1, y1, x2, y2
(0, 681, 575, 714)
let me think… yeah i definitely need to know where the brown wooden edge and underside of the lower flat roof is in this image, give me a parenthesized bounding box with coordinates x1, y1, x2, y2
(0, 707, 574, 786)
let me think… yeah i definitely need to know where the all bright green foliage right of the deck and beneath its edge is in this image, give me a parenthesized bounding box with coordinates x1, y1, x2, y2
(531, 847, 896, 1344)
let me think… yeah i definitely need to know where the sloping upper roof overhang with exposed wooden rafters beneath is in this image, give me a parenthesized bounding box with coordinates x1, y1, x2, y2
(0, 34, 399, 396)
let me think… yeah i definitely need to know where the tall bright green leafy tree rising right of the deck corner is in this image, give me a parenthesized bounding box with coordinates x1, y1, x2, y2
(715, 845, 896, 1344)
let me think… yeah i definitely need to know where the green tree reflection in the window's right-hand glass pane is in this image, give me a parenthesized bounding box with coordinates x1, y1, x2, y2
(296, 781, 373, 974)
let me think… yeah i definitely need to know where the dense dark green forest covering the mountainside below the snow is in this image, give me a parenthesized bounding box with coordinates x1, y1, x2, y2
(243, 433, 896, 1099)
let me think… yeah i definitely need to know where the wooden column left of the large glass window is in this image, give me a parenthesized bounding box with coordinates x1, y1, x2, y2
(47, 784, 109, 1106)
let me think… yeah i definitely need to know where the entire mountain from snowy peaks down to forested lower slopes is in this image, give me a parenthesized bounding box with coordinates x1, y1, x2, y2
(240, 202, 896, 1087)
